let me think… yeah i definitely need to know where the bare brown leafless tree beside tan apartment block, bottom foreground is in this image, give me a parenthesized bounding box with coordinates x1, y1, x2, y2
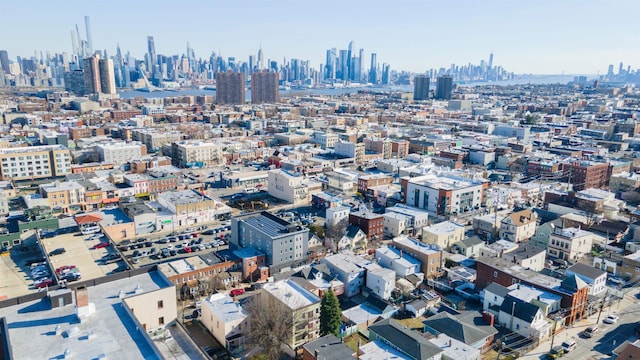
(244, 295, 293, 360)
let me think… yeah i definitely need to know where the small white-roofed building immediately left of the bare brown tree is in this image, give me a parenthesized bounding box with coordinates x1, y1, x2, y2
(200, 293, 250, 352)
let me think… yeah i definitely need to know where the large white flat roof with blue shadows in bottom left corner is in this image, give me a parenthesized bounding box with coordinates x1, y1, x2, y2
(0, 271, 171, 359)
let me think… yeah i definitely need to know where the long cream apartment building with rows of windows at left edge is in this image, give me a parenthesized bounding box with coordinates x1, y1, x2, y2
(0, 145, 71, 180)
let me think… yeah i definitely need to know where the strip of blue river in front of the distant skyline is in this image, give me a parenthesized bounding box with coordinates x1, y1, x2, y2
(119, 75, 574, 100)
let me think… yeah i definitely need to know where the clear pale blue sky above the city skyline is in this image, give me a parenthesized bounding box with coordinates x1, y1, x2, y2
(0, 0, 640, 74)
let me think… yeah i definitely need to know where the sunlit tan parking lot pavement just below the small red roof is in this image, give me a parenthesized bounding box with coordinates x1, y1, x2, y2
(41, 233, 124, 280)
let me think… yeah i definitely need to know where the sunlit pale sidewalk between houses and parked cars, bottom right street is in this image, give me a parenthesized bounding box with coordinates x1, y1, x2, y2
(518, 295, 634, 360)
